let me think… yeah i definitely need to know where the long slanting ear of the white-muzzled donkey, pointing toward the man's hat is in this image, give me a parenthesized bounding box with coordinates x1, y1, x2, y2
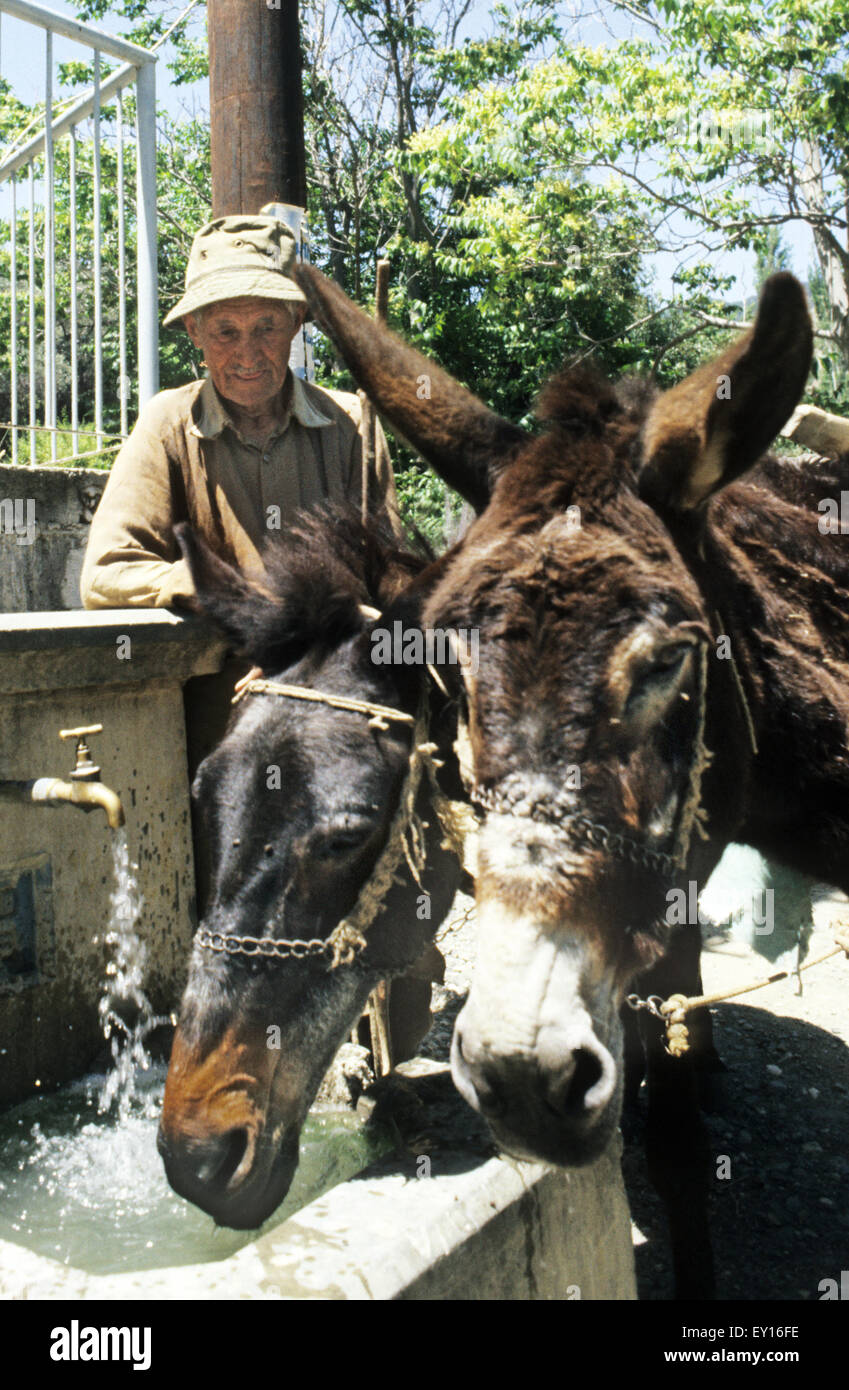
(295, 265, 529, 512)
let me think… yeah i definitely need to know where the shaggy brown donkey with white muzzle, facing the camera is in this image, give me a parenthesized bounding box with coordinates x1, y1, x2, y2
(299, 267, 849, 1295)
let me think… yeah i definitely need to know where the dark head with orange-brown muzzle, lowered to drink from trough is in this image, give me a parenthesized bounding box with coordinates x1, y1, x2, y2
(158, 509, 463, 1229)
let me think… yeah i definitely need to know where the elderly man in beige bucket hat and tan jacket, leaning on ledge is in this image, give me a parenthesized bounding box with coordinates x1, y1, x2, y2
(81, 215, 397, 609)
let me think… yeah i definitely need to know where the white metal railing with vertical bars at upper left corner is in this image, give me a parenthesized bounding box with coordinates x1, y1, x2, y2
(0, 0, 158, 463)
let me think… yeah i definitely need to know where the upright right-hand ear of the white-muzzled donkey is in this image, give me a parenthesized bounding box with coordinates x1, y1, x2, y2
(638, 271, 813, 512)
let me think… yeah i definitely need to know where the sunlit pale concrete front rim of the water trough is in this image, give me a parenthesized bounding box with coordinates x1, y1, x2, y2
(0, 1100, 636, 1300)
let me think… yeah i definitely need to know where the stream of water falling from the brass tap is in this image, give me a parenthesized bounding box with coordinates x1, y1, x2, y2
(97, 830, 170, 1120)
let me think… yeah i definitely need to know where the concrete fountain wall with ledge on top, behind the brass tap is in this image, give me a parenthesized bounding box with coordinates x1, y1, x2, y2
(0, 610, 222, 1104)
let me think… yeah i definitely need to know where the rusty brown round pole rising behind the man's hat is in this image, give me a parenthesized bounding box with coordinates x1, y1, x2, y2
(207, 0, 307, 217)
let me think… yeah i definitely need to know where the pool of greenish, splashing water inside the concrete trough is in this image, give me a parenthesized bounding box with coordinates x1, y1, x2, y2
(0, 1063, 393, 1275)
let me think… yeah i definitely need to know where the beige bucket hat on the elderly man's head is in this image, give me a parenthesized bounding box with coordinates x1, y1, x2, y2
(163, 214, 307, 327)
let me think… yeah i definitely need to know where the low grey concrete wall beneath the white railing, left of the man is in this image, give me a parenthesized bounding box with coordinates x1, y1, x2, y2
(0, 463, 108, 613)
